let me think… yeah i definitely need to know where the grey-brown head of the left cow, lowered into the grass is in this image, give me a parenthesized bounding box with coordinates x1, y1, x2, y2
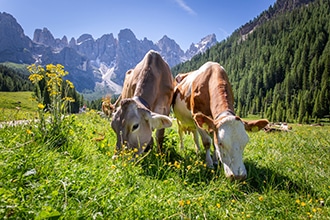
(111, 99, 172, 153)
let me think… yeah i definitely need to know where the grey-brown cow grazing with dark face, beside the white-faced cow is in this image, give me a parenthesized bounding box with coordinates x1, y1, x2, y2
(111, 50, 174, 153)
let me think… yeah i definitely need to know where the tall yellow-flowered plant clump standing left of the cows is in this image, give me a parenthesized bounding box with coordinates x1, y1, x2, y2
(28, 64, 75, 148)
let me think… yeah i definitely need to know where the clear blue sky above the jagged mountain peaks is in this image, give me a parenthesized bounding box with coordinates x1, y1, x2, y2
(0, 0, 275, 50)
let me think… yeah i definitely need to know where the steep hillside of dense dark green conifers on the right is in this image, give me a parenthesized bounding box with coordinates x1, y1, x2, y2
(172, 0, 330, 123)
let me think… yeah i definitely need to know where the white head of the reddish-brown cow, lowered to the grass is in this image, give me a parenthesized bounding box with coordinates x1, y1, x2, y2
(194, 113, 249, 180)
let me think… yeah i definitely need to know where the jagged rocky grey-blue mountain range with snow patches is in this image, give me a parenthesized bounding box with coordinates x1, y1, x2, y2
(0, 12, 217, 95)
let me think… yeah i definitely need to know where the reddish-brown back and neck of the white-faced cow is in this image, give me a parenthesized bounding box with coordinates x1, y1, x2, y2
(176, 62, 234, 117)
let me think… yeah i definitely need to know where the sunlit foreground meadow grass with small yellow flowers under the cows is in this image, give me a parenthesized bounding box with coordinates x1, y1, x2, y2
(0, 112, 330, 219)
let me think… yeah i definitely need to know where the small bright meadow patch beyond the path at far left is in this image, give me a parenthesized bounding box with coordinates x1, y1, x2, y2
(0, 92, 37, 122)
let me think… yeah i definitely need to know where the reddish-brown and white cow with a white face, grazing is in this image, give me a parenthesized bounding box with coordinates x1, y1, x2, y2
(173, 62, 268, 179)
